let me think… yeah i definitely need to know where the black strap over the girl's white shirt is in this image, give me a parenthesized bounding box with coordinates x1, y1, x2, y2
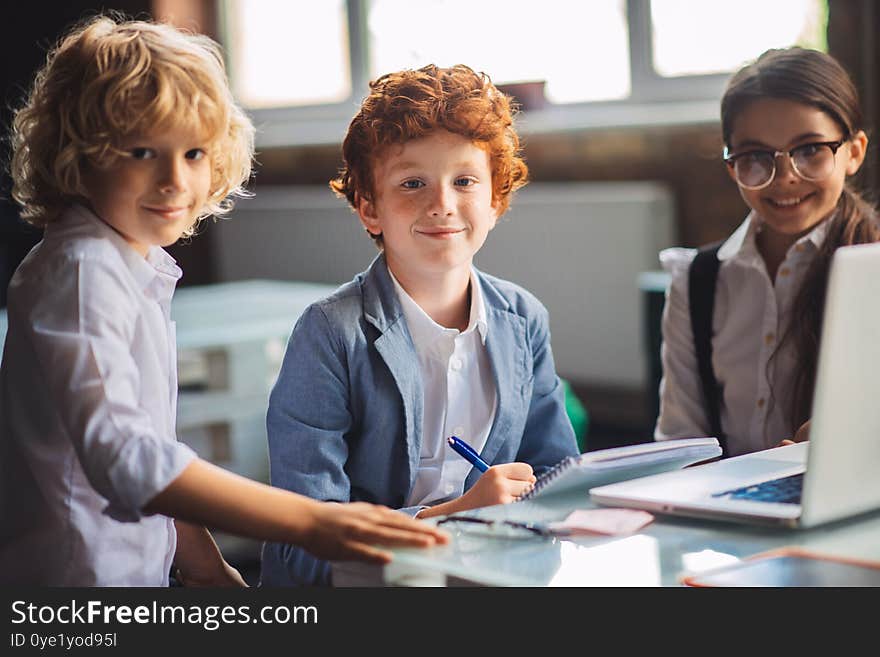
(688, 243, 727, 456)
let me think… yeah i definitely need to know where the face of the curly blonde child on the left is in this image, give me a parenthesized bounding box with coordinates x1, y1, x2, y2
(84, 128, 211, 256)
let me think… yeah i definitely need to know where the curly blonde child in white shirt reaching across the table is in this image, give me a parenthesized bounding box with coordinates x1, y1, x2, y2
(0, 17, 444, 586)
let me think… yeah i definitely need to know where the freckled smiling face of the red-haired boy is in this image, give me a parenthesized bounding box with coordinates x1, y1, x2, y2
(358, 130, 498, 287)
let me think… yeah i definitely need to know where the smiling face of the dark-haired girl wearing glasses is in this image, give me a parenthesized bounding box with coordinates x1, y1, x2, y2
(728, 98, 868, 239)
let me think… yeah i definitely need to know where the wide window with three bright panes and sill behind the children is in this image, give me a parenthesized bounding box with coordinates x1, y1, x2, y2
(222, 0, 827, 147)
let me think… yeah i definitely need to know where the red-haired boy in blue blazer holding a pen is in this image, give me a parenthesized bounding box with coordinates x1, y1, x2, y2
(262, 66, 577, 584)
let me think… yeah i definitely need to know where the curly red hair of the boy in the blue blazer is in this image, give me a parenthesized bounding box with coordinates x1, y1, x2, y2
(330, 64, 528, 244)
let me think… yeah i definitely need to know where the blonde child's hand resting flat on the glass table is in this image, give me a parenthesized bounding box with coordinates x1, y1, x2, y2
(300, 502, 449, 563)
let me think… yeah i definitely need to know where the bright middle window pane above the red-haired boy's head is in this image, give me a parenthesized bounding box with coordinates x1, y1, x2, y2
(368, 0, 630, 103)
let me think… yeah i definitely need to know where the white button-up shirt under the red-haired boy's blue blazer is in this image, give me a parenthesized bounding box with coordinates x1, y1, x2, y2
(389, 270, 497, 506)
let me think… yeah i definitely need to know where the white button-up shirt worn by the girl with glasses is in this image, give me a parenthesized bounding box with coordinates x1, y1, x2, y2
(654, 213, 830, 455)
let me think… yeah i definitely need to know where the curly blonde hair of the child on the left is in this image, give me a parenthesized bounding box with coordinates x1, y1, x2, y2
(11, 16, 254, 237)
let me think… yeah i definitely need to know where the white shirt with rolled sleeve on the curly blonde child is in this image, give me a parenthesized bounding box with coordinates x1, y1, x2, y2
(0, 206, 195, 586)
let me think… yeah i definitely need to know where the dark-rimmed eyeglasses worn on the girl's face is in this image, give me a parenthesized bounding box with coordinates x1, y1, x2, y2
(724, 137, 849, 190)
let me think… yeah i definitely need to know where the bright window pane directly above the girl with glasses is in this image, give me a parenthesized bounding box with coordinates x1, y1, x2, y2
(651, 0, 828, 77)
